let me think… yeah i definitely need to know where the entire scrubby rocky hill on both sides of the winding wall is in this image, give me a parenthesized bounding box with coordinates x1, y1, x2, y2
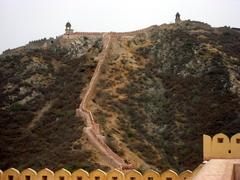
(0, 21, 240, 171)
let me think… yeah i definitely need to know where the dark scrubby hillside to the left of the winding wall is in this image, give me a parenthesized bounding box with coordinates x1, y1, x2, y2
(0, 35, 109, 170)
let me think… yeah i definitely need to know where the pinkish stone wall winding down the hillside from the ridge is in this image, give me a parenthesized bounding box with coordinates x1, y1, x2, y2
(76, 33, 131, 170)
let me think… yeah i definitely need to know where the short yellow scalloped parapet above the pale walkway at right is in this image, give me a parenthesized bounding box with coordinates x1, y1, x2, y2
(203, 133, 240, 161)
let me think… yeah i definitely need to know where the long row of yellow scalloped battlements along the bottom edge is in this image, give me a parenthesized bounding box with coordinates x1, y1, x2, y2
(0, 168, 194, 180)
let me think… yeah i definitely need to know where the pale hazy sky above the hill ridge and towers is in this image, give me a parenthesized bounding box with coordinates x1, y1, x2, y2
(0, 0, 240, 53)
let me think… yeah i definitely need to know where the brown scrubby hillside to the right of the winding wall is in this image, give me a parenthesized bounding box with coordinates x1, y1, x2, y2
(91, 21, 240, 171)
